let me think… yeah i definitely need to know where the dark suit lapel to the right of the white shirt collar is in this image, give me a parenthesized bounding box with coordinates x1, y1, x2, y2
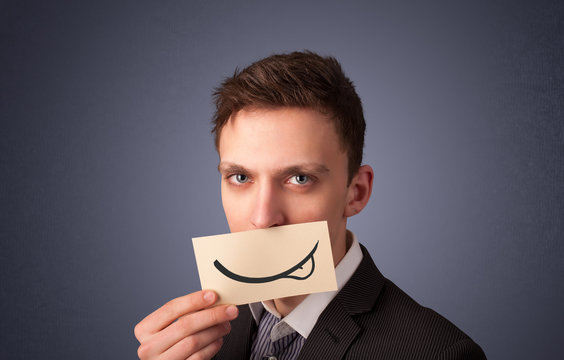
(298, 245, 384, 360)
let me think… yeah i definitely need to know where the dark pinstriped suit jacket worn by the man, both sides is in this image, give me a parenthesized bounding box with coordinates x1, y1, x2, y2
(214, 245, 486, 360)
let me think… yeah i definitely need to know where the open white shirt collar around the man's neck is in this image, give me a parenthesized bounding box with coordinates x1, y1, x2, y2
(249, 230, 362, 341)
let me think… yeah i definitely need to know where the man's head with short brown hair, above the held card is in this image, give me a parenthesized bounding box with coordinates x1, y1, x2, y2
(209, 53, 373, 264)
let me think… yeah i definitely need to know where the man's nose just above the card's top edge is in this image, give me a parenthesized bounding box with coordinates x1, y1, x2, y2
(251, 183, 285, 229)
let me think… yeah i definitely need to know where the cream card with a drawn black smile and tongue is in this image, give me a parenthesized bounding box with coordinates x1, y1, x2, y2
(192, 221, 337, 305)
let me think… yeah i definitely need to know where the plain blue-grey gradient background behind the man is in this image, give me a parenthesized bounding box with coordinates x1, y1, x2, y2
(0, 0, 564, 359)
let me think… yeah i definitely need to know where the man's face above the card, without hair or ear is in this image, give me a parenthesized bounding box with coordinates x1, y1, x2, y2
(218, 108, 351, 263)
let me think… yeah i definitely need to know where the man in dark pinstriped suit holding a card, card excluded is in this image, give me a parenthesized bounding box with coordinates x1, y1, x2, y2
(135, 52, 485, 360)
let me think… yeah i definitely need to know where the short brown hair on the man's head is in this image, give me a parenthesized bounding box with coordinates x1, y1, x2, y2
(212, 51, 366, 183)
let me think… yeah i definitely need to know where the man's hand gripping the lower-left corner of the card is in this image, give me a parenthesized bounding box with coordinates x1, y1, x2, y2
(135, 290, 239, 359)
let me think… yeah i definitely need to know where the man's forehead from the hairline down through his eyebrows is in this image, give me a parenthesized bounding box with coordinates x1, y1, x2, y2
(218, 108, 346, 173)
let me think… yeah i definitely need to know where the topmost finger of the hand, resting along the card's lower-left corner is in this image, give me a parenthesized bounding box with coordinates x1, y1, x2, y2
(135, 290, 217, 342)
